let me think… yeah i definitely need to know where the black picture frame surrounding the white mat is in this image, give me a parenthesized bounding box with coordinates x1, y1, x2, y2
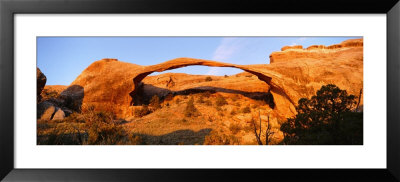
(0, 0, 400, 181)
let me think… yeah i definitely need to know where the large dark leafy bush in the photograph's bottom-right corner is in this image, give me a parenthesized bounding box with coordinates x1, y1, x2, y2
(280, 84, 363, 145)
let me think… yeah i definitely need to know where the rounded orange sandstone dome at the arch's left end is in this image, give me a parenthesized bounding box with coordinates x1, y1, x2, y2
(71, 59, 144, 116)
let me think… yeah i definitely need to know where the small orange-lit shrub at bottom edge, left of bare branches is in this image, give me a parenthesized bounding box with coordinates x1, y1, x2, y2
(204, 131, 239, 145)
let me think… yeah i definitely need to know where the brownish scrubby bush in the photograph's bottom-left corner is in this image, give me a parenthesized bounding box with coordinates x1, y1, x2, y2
(37, 108, 129, 145)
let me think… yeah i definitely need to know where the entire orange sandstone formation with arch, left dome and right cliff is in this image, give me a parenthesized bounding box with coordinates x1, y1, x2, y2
(50, 39, 363, 117)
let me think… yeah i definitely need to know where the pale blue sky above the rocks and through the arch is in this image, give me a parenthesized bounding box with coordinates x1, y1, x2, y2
(37, 37, 360, 85)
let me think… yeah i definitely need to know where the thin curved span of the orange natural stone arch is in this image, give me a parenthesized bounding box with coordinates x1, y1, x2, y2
(130, 58, 293, 105)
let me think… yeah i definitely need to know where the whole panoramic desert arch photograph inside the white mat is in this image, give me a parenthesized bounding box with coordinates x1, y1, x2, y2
(36, 36, 363, 145)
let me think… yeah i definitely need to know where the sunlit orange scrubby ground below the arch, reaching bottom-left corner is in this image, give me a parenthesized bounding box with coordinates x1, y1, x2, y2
(38, 92, 280, 145)
